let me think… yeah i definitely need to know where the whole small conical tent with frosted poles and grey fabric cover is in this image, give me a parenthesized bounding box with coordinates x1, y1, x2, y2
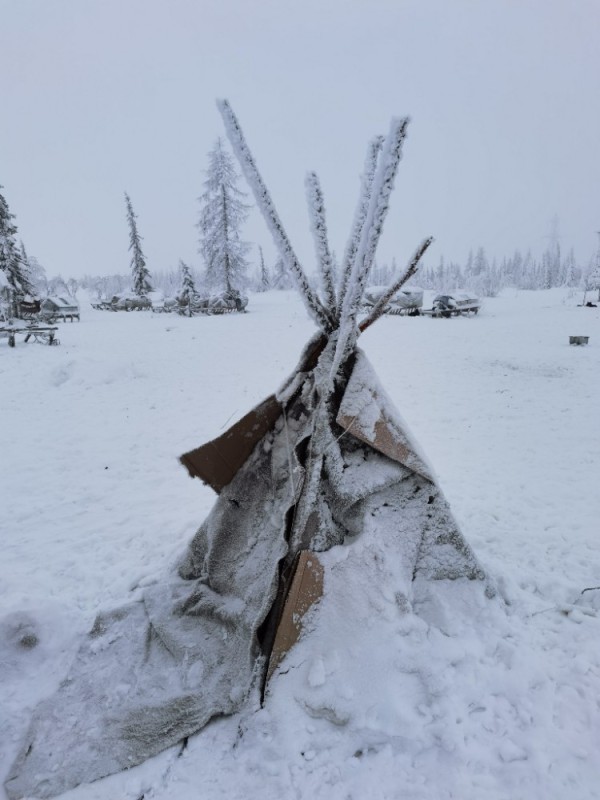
(5, 101, 494, 800)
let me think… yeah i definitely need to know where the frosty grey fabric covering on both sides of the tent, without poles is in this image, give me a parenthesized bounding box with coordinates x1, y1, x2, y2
(6, 350, 483, 798)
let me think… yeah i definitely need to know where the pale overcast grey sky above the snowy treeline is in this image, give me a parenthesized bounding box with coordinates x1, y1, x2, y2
(0, 0, 600, 278)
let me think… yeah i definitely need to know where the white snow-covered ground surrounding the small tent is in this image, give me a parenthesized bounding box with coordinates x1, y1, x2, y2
(0, 290, 600, 800)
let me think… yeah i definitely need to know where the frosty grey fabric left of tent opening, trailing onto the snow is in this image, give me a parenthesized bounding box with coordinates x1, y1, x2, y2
(6, 412, 301, 798)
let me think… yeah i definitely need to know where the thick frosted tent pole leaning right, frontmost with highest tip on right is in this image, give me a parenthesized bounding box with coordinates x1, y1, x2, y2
(331, 117, 409, 377)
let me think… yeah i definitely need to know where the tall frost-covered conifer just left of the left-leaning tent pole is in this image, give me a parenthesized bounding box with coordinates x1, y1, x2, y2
(198, 138, 250, 292)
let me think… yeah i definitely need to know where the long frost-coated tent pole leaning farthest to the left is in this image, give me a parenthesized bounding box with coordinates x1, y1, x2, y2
(217, 100, 333, 332)
